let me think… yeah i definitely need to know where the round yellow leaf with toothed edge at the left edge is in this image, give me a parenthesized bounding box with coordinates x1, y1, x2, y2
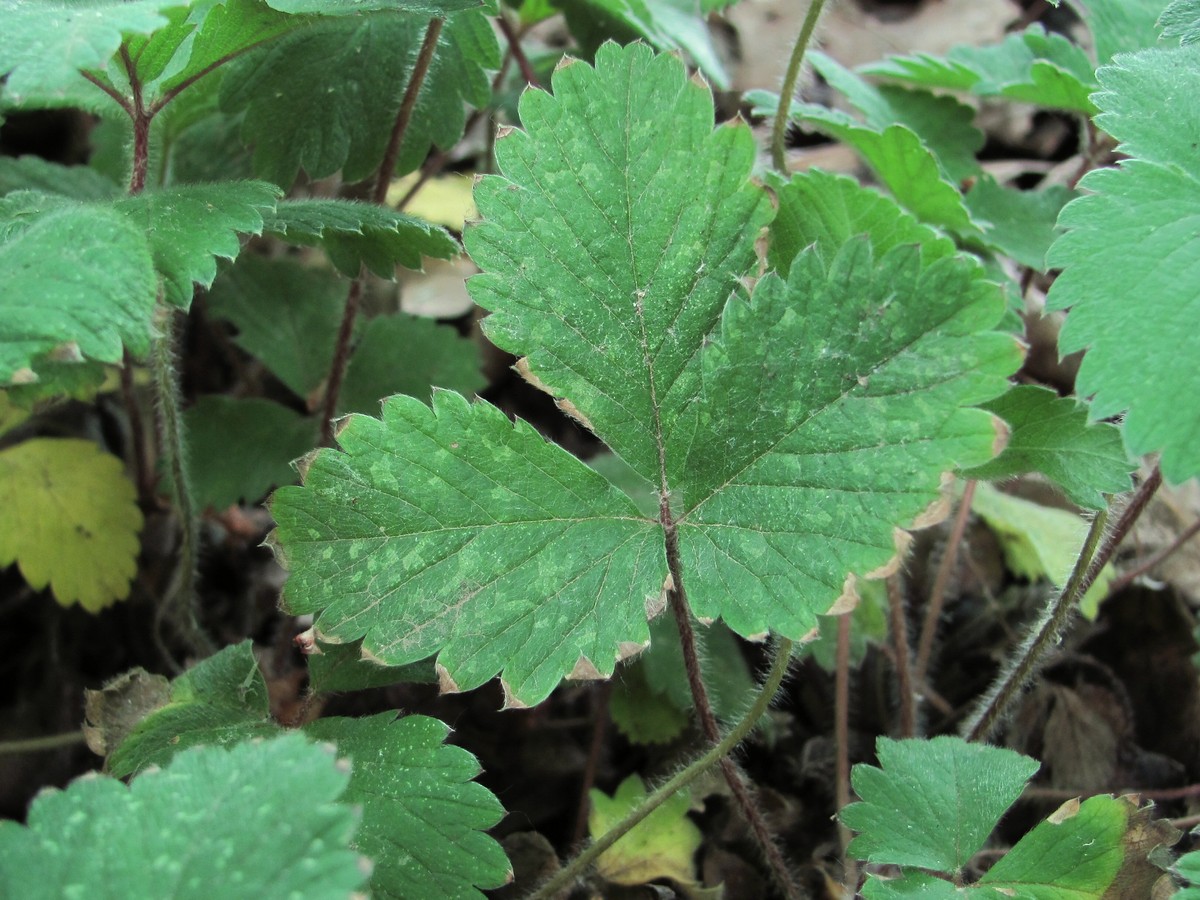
(0, 438, 142, 612)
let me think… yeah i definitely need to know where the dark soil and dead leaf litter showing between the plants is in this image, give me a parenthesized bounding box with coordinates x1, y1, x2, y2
(0, 0, 1200, 898)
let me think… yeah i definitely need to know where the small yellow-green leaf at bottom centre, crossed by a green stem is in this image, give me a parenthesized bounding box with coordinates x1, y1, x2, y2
(588, 775, 701, 884)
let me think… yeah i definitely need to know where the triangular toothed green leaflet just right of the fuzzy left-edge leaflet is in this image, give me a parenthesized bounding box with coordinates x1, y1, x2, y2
(115, 181, 280, 310)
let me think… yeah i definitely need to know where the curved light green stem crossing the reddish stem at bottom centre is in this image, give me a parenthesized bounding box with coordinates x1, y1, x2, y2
(530, 638, 792, 900)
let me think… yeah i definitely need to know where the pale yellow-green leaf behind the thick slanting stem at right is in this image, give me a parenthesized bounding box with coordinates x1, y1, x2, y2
(971, 484, 1116, 619)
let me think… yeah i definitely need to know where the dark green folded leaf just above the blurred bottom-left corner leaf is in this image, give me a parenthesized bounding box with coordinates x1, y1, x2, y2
(104, 641, 280, 778)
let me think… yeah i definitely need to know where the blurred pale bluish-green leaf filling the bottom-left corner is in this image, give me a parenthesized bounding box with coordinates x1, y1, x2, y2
(0, 734, 366, 900)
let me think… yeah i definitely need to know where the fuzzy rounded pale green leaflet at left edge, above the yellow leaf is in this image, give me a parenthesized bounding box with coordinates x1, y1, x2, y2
(0, 199, 157, 384)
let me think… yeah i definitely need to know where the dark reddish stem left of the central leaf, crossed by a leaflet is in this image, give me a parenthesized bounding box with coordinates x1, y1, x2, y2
(320, 18, 445, 446)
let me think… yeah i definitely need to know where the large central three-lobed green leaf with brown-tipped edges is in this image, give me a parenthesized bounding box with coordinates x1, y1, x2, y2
(272, 44, 1019, 703)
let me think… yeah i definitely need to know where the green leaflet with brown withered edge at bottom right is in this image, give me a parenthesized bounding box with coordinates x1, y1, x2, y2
(979, 797, 1133, 900)
